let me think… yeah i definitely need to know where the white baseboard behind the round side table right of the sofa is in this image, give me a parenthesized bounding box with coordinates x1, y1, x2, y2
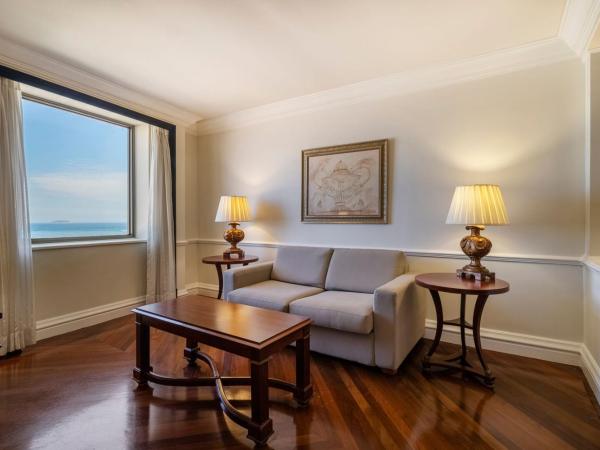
(425, 319, 582, 366)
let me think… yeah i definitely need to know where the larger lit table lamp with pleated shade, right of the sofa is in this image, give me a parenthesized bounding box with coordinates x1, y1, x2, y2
(446, 184, 508, 281)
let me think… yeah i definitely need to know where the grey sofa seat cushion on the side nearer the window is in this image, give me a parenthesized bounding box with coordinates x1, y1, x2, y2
(227, 280, 322, 312)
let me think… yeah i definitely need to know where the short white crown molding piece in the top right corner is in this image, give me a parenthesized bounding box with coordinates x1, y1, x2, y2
(558, 0, 600, 56)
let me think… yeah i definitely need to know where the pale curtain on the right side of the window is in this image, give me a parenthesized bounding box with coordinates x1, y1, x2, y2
(146, 126, 176, 303)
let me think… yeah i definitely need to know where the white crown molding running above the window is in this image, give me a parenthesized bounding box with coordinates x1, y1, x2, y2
(0, 37, 201, 127)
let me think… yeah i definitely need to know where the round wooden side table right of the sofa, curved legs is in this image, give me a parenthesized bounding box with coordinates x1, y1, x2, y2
(415, 273, 510, 388)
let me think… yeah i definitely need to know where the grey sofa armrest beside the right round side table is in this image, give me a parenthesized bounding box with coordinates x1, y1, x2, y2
(373, 273, 426, 370)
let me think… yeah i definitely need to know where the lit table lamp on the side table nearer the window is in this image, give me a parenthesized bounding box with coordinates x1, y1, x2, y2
(215, 195, 250, 259)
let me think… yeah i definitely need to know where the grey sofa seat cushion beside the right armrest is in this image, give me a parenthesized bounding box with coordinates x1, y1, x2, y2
(290, 291, 373, 334)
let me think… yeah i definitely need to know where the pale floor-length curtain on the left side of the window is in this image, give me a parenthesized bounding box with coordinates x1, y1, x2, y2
(0, 78, 35, 355)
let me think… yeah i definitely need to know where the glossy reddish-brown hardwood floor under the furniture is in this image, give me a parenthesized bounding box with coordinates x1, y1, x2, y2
(0, 317, 600, 450)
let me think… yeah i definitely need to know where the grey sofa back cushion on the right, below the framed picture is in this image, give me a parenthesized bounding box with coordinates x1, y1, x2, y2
(325, 248, 406, 294)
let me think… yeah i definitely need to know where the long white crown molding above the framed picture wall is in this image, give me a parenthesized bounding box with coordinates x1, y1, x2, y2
(197, 38, 575, 135)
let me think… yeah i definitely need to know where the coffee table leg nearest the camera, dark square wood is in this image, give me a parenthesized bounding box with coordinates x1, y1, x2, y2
(248, 359, 273, 445)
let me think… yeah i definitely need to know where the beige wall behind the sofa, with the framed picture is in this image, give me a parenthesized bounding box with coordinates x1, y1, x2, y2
(188, 61, 585, 341)
